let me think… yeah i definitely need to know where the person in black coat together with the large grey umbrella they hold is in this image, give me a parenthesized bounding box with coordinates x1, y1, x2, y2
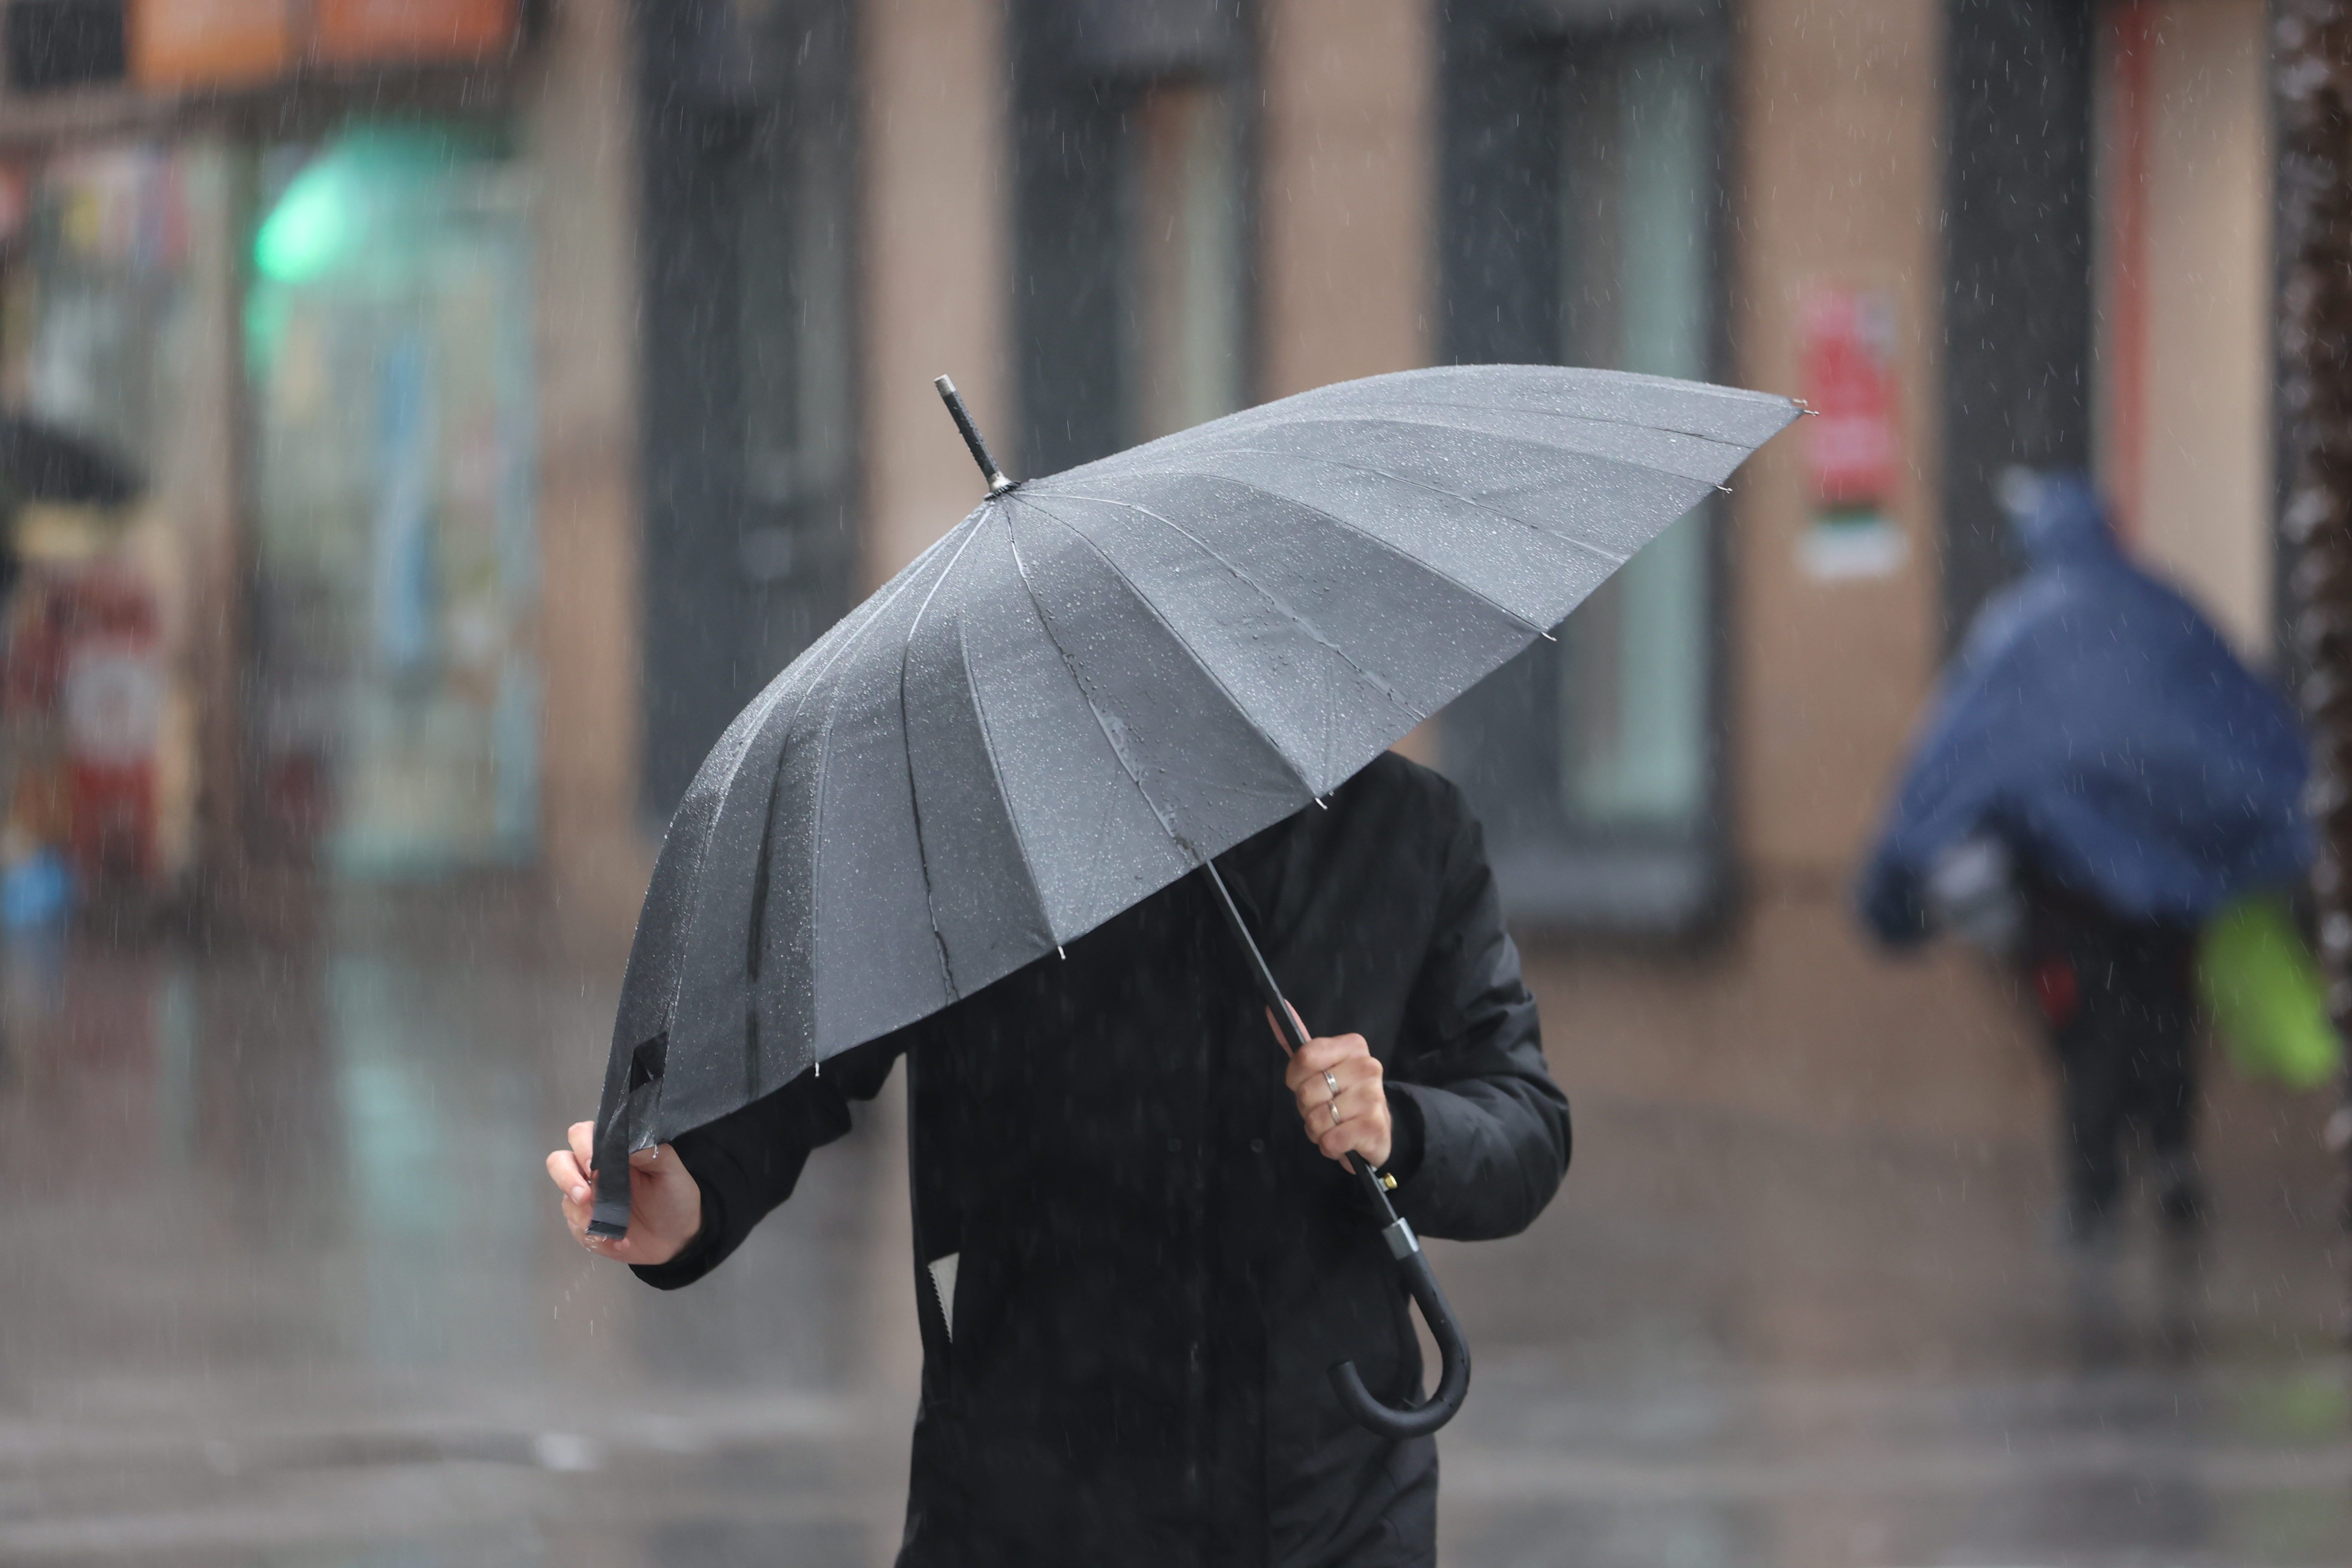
(548, 367, 1795, 1568)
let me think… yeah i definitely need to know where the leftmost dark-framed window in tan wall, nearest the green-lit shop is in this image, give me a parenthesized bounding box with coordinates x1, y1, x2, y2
(637, 0, 861, 818)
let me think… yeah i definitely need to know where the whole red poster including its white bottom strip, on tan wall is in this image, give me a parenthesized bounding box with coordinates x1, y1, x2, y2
(1797, 287, 1905, 578)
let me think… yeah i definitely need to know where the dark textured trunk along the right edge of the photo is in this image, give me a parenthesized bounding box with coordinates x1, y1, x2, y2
(2274, 0, 2352, 1328)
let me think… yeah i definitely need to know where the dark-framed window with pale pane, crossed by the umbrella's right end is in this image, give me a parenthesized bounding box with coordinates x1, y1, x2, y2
(1442, 5, 1726, 931)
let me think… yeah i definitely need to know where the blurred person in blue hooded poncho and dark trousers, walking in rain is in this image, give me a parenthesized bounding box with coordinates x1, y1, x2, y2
(1860, 472, 2312, 1246)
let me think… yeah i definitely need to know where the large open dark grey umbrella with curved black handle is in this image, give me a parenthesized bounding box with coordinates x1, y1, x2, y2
(590, 364, 1797, 1436)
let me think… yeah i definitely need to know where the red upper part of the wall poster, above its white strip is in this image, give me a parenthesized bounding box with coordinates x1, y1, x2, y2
(1799, 287, 1898, 512)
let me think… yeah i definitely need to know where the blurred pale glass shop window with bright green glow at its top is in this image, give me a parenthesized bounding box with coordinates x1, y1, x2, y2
(245, 127, 539, 875)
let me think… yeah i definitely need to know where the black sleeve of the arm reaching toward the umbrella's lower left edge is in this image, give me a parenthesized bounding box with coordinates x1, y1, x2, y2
(633, 1034, 906, 1291)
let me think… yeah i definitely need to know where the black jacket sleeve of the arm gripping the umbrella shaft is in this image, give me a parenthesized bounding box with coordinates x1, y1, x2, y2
(1387, 792, 1569, 1241)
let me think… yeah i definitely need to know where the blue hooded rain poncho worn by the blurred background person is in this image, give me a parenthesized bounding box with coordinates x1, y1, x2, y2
(1860, 475, 2312, 943)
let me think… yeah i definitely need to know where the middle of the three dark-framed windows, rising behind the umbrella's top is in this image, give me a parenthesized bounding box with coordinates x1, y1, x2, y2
(1011, 0, 1254, 472)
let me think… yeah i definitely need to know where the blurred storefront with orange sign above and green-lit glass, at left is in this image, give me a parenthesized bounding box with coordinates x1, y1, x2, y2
(0, 0, 633, 931)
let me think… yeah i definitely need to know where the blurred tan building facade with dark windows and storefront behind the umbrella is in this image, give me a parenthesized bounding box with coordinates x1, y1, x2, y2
(0, 0, 2277, 1133)
